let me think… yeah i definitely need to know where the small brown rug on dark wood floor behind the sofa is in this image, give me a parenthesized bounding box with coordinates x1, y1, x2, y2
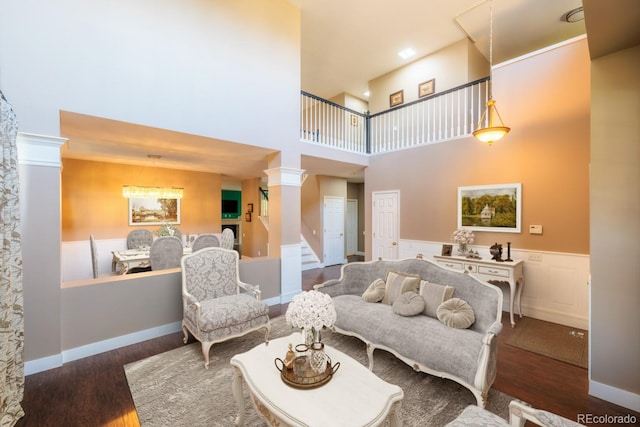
(505, 317, 589, 369)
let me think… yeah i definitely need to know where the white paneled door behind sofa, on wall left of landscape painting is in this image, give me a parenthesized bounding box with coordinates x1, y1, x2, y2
(371, 191, 400, 259)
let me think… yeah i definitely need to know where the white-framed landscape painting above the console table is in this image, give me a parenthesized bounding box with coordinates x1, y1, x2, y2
(458, 183, 522, 233)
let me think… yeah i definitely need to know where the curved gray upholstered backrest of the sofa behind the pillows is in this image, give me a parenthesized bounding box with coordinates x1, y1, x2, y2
(323, 258, 502, 333)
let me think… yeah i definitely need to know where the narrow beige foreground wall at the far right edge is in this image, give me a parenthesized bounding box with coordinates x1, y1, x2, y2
(589, 46, 640, 398)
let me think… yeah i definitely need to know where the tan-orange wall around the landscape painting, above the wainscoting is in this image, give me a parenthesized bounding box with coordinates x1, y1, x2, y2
(365, 40, 590, 256)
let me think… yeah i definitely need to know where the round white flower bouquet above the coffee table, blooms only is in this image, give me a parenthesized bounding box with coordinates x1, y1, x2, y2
(285, 290, 336, 331)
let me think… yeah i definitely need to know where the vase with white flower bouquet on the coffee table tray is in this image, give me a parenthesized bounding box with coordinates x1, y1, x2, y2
(285, 290, 336, 374)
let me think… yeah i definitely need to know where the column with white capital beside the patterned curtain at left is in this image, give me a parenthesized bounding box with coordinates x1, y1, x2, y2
(16, 132, 66, 375)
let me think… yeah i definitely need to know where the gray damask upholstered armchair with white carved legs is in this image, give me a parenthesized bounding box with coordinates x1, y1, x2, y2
(181, 247, 271, 368)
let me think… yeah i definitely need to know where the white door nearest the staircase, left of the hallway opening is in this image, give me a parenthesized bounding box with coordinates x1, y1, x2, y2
(322, 197, 346, 265)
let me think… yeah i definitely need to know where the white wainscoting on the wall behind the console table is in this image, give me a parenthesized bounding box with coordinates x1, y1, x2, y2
(399, 239, 590, 330)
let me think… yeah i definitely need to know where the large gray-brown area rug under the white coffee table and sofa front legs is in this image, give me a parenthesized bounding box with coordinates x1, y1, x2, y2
(124, 316, 512, 427)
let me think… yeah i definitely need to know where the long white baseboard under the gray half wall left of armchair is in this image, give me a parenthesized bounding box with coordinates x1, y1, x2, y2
(24, 322, 181, 375)
